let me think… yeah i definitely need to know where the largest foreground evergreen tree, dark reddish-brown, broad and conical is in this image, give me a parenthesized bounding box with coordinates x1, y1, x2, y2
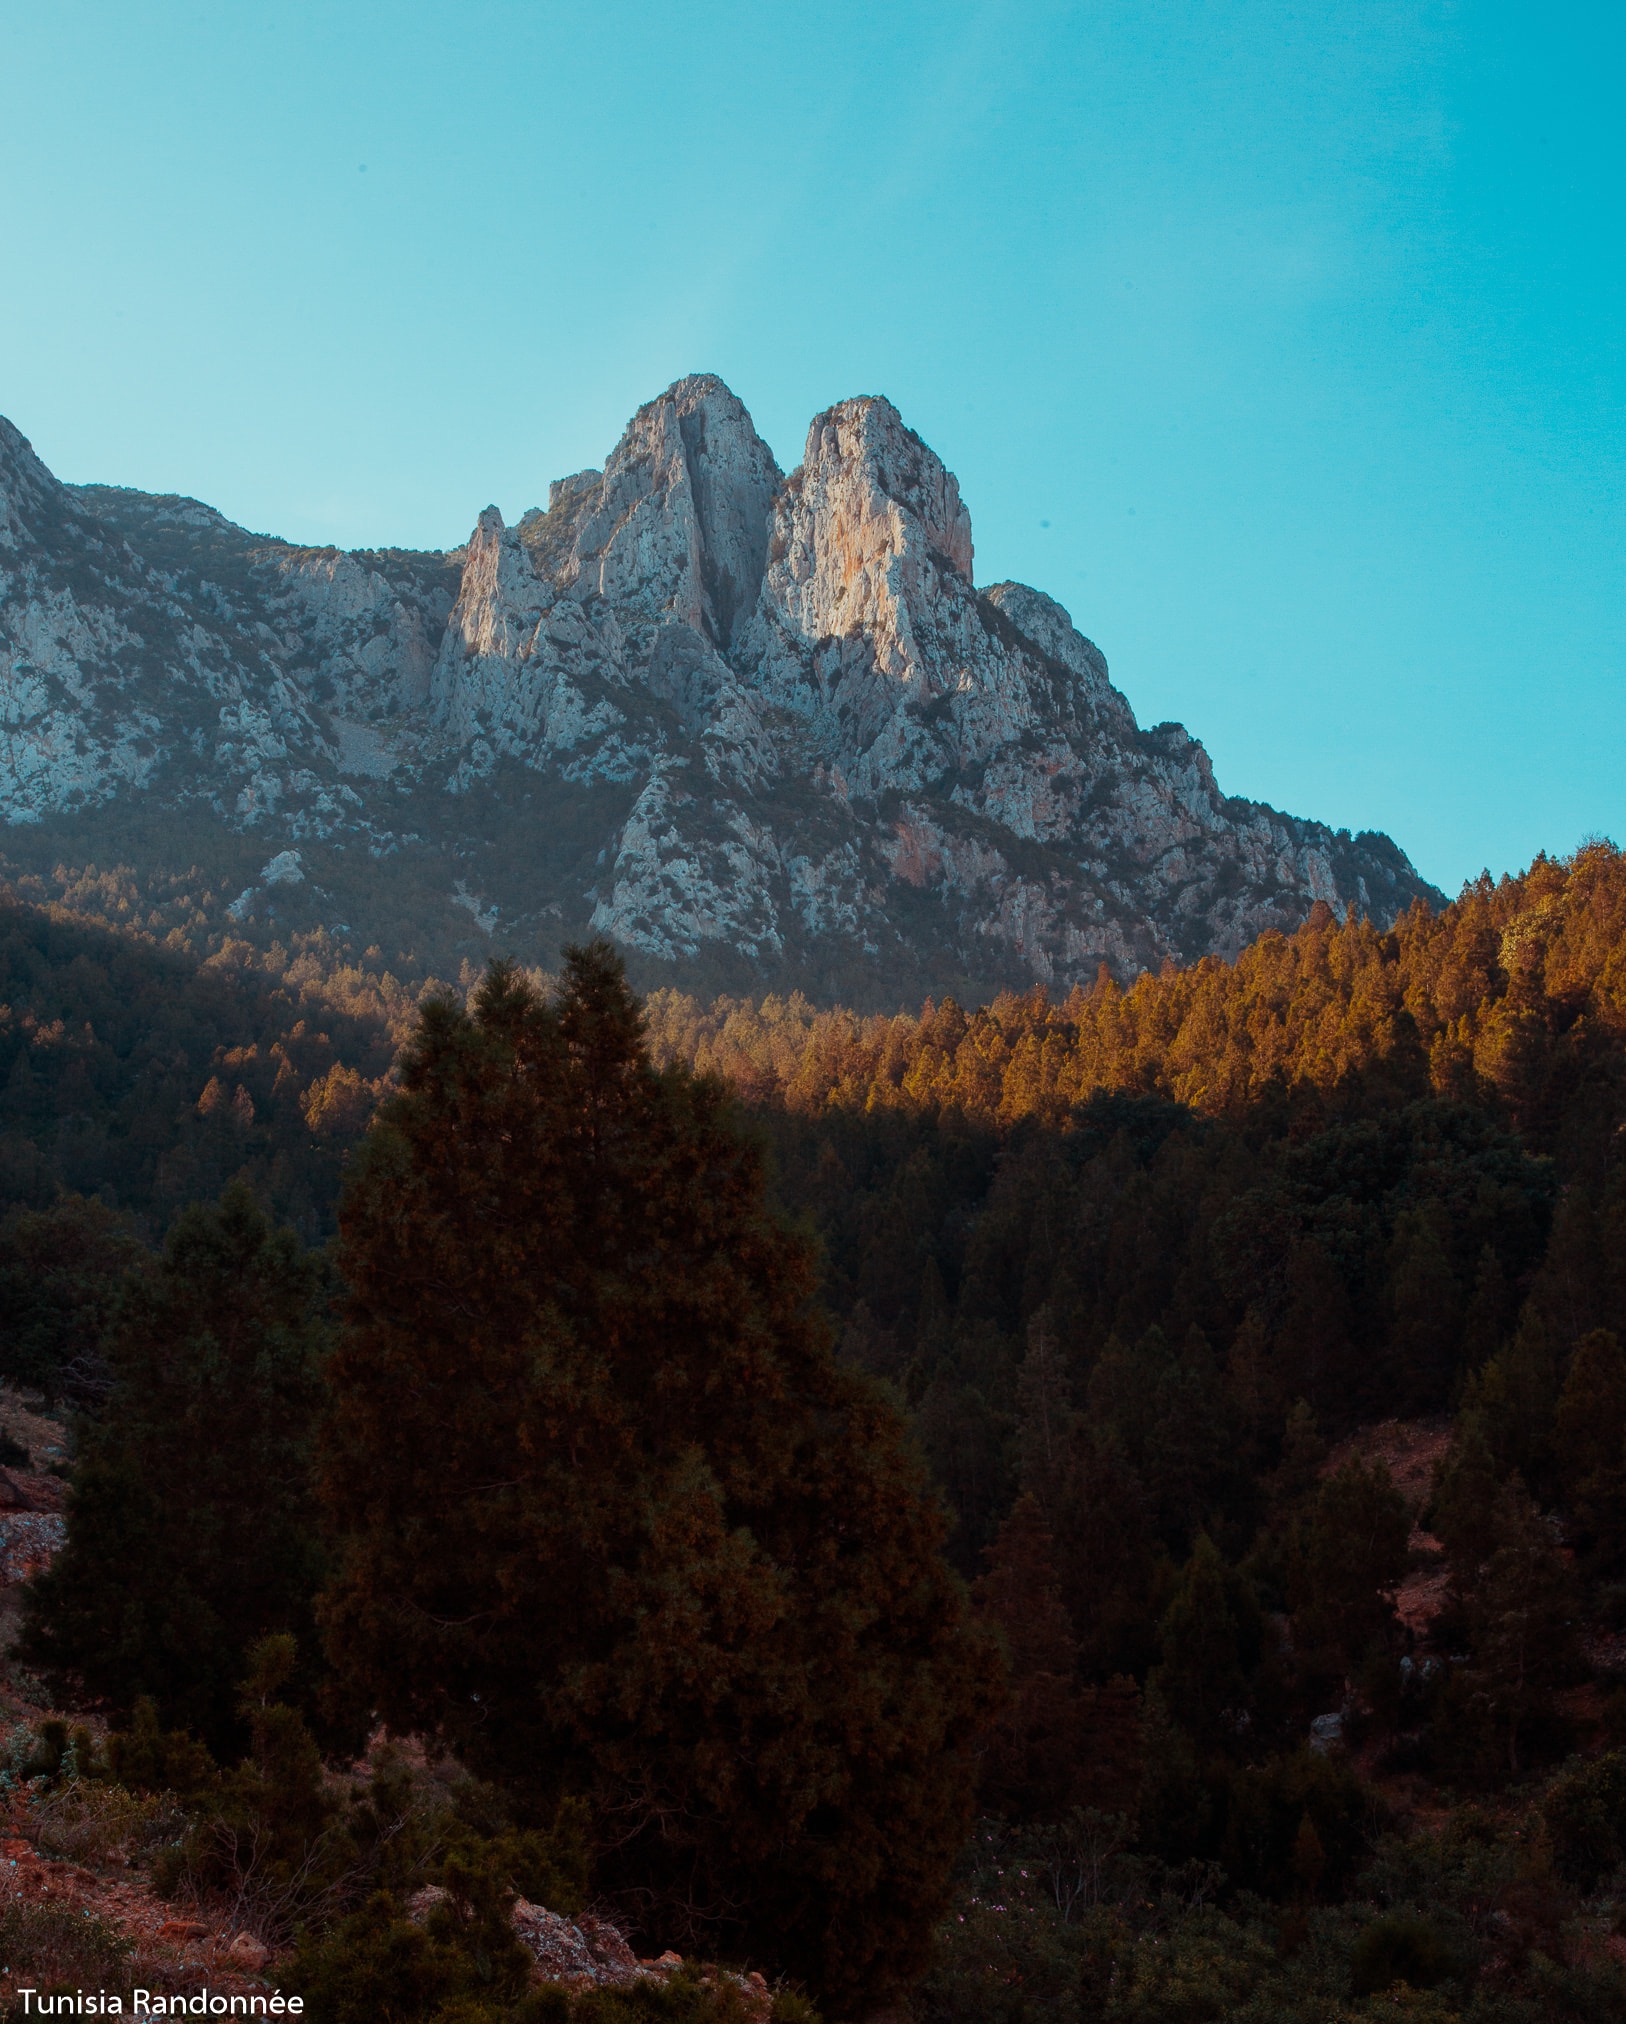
(324, 943, 998, 2002)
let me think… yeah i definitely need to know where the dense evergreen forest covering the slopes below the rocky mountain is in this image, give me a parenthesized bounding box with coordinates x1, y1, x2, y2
(0, 844, 1626, 2024)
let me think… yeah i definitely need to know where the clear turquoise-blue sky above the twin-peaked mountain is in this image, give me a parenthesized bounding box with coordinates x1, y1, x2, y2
(0, 0, 1626, 889)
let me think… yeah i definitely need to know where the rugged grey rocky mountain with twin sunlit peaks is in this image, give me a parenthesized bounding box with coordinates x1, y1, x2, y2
(0, 374, 1438, 1004)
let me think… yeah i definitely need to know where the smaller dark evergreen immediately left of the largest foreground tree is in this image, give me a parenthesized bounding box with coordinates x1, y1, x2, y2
(20, 1184, 324, 1755)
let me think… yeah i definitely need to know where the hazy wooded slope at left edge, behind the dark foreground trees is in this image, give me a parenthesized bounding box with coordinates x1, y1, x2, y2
(0, 874, 402, 1230)
